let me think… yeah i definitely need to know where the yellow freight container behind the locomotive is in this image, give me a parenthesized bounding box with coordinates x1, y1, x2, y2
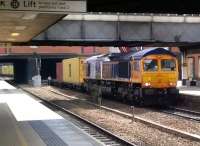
(62, 57, 85, 84)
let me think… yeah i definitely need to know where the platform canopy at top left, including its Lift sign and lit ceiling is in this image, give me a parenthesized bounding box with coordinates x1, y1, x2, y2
(0, 0, 86, 43)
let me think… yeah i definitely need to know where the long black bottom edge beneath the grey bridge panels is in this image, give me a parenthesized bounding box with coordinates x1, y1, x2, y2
(14, 40, 200, 48)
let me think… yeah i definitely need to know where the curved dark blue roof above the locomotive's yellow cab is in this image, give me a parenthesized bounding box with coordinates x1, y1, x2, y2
(121, 48, 176, 60)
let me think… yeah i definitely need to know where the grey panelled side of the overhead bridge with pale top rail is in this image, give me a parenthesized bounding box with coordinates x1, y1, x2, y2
(18, 15, 200, 46)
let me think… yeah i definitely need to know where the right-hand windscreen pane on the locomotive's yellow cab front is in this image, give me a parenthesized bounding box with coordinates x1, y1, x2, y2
(161, 59, 176, 71)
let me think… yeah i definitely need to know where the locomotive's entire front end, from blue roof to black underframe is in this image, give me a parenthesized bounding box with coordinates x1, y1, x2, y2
(131, 48, 179, 104)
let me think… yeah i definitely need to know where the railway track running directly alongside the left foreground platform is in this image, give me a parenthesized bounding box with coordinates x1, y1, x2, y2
(20, 88, 137, 146)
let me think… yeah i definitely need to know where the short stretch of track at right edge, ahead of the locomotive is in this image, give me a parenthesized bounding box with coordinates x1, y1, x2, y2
(161, 107, 200, 122)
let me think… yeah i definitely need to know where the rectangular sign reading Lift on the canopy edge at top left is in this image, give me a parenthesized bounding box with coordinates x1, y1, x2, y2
(0, 0, 87, 12)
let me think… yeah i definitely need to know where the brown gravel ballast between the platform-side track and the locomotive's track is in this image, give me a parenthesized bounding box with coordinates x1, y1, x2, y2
(22, 86, 200, 146)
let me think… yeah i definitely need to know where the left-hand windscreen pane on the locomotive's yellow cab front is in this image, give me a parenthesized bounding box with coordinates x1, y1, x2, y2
(144, 59, 158, 71)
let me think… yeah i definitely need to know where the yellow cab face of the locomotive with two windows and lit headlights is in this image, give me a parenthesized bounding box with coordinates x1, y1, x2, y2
(141, 55, 178, 89)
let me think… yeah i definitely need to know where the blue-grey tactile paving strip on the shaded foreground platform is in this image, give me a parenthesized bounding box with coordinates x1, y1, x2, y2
(29, 121, 68, 146)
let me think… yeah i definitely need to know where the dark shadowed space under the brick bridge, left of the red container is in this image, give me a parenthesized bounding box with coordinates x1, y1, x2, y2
(0, 54, 76, 83)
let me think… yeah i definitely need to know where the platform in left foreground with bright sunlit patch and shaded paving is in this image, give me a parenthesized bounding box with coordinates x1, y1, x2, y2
(0, 81, 103, 146)
